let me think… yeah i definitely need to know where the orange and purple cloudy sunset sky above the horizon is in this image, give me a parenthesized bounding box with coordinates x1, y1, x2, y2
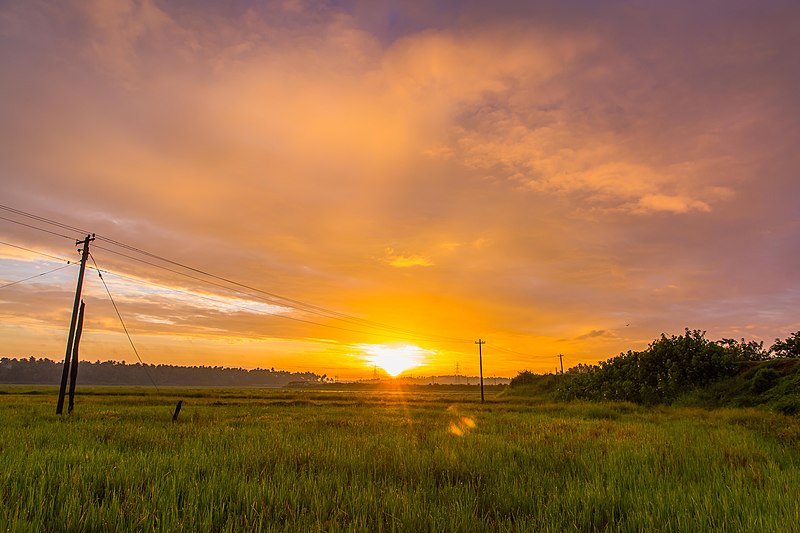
(0, 0, 800, 379)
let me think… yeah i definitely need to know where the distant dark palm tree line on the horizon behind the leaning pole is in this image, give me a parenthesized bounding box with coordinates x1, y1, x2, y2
(0, 357, 325, 387)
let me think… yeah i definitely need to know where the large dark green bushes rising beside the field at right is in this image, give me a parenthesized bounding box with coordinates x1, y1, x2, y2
(508, 329, 800, 414)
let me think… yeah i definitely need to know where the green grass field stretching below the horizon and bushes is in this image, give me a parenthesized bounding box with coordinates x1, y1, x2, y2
(0, 386, 800, 532)
